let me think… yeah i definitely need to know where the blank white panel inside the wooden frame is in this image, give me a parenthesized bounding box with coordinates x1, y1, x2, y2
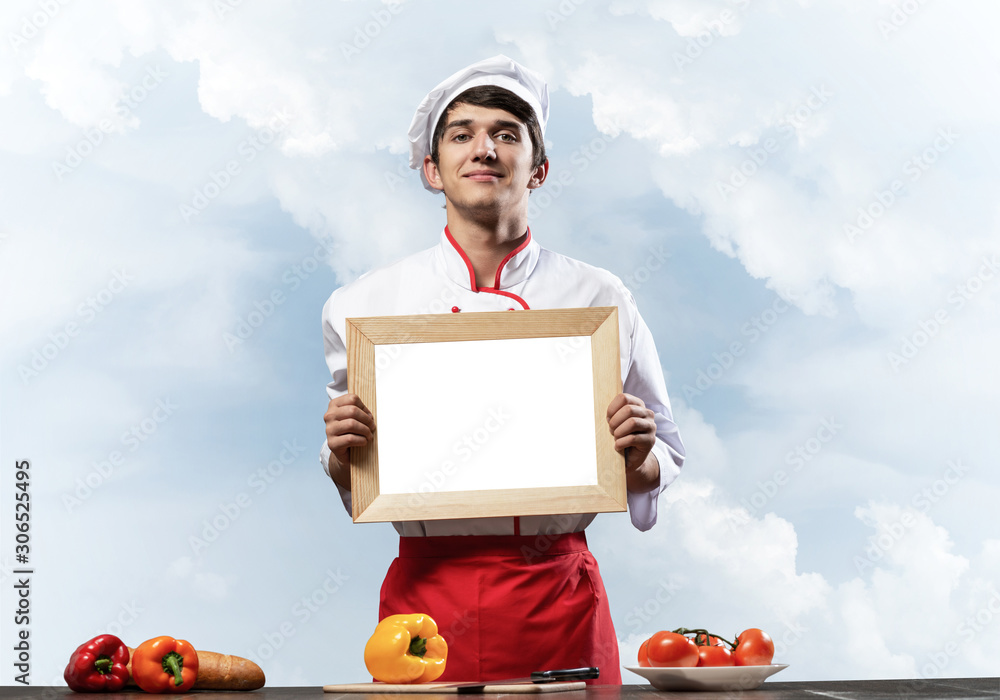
(374, 336, 592, 494)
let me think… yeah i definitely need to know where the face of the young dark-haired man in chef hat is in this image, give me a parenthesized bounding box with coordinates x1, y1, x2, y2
(424, 104, 548, 218)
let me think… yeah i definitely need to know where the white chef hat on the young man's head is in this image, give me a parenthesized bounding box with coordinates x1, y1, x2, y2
(408, 55, 549, 193)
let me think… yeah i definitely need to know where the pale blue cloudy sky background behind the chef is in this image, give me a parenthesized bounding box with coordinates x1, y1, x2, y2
(0, 0, 1000, 685)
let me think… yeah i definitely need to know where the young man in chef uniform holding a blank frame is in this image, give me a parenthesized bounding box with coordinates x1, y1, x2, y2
(321, 56, 684, 684)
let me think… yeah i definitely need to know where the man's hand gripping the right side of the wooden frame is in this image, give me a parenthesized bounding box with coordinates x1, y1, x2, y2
(608, 393, 660, 493)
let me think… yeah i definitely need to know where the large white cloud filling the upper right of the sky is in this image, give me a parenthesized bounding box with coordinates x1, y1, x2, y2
(504, 3, 998, 318)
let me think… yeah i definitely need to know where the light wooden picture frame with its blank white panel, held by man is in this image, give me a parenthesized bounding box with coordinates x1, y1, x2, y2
(347, 306, 627, 522)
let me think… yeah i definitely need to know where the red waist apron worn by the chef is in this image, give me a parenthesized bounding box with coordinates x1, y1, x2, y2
(379, 532, 621, 685)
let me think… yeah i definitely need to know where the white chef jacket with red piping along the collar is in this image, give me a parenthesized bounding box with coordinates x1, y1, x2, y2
(320, 227, 684, 537)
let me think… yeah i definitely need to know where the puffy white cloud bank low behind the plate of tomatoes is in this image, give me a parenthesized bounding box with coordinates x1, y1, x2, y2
(597, 479, 1000, 678)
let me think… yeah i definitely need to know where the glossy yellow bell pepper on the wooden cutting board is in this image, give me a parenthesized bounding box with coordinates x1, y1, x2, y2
(365, 613, 448, 683)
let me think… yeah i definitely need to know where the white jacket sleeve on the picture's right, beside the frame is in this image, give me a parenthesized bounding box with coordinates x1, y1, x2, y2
(620, 289, 684, 531)
